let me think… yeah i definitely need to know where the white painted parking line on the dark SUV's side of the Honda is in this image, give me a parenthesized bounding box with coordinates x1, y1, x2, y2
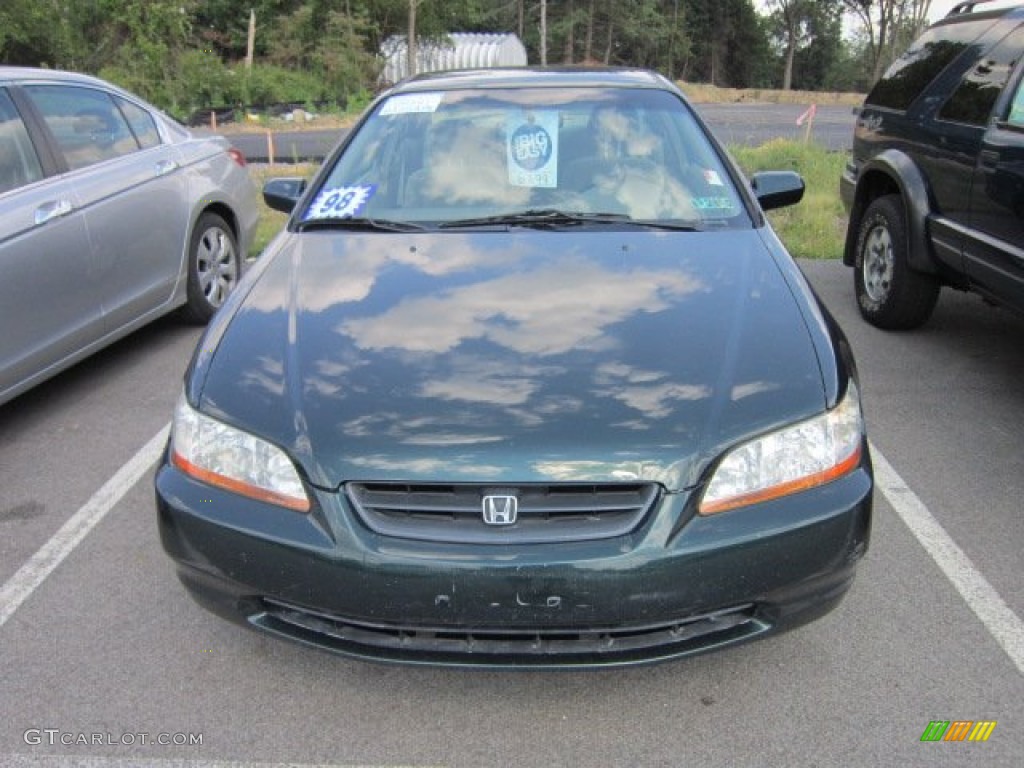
(871, 444, 1024, 674)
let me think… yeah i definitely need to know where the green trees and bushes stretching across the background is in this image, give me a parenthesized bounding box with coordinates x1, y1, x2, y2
(0, 0, 872, 116)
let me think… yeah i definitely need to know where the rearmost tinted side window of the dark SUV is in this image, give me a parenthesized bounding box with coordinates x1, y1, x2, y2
(867, 18, 992, 111)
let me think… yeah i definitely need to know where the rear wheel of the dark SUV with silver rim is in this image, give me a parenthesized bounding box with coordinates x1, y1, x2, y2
(853, 195, 940, 331)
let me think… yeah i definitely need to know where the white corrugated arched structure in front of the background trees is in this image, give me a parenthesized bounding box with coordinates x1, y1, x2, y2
(381, 33, 526, 83)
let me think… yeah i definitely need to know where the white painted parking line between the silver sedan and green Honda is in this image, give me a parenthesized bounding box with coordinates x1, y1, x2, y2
(0, 424, 171, 627)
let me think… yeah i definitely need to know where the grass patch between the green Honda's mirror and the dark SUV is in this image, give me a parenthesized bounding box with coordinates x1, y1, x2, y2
(729, 139, 847, 259)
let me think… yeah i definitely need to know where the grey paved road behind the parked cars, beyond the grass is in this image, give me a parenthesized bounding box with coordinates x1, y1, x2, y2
(225, 103, 855, 163)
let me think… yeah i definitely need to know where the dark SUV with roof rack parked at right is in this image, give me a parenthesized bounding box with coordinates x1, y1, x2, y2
(840, 2, 1024, 330)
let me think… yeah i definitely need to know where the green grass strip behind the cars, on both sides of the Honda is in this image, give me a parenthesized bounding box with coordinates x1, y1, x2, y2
(241, 139, 846, 259)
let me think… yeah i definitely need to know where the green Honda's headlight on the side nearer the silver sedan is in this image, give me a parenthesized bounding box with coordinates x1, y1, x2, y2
(171, 394, 309, 512)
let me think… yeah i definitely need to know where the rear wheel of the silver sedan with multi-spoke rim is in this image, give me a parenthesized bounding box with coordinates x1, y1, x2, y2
(182, 213, 240, 324)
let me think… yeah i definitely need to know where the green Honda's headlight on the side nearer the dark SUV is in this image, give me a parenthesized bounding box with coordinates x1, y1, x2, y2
(698, 381, 863, 515)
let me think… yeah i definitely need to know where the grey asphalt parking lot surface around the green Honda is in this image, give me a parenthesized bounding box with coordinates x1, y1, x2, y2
(0, 262, 1024, 768)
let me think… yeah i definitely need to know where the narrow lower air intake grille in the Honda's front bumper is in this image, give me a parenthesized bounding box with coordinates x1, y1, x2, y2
(256, 598, 771, 667)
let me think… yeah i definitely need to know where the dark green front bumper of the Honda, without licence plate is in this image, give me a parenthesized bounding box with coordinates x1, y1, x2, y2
(156, 456, 871, 667)
